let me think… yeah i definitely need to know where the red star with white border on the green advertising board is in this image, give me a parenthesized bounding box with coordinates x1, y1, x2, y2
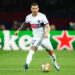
(53, 31, 75, 50)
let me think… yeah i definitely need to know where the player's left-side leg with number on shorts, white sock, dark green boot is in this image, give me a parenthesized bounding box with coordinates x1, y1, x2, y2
(24, 37, 40, 71)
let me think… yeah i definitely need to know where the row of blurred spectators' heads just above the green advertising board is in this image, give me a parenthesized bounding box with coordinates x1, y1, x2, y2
(0, 20, 75, 30)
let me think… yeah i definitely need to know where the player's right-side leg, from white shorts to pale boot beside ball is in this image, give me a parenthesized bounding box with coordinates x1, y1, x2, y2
(41, 38, 60, 70)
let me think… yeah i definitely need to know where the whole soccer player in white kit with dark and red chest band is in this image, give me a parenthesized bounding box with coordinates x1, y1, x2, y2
(15, 3, 60, 71)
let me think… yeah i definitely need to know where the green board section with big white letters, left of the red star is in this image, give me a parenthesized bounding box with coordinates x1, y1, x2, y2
(0, 30, 43, 50)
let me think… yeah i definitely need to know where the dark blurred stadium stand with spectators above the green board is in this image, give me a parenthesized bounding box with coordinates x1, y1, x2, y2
(0, 0, 75, 30)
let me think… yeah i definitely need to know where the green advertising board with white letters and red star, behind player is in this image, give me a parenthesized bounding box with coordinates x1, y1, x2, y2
(0, 30, 75, 50)
